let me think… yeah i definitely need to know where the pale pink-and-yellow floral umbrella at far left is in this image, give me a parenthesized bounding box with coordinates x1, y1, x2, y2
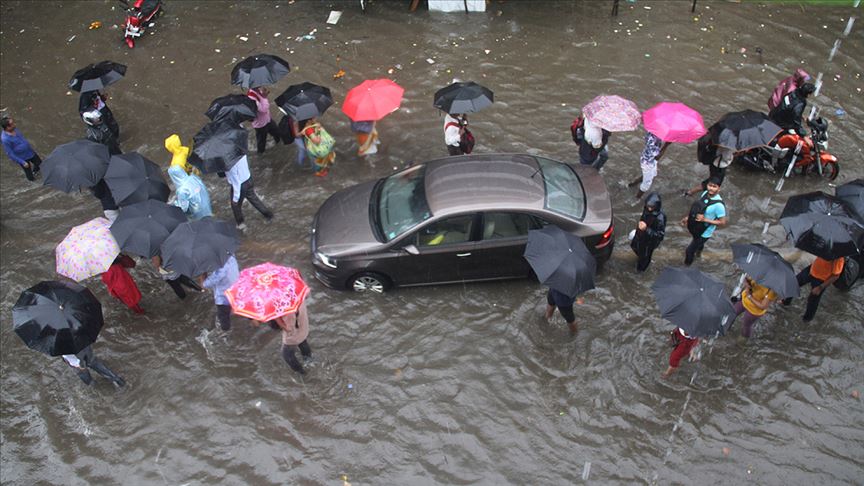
(55, 218, 120, 282)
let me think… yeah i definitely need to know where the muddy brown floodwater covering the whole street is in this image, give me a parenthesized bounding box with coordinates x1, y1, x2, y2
(0, 0, 864, 486)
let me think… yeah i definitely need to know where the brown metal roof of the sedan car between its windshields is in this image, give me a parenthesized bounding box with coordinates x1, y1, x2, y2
(425, 154, 546, 216)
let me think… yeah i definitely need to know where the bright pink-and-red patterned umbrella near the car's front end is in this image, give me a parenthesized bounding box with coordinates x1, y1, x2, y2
(225, 262, 309, 322)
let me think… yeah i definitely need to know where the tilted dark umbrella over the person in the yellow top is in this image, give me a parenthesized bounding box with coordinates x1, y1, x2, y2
(732, 243, 799, 299)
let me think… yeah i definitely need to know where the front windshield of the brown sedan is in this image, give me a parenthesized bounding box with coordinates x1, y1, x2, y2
(377, 165, 431, 241)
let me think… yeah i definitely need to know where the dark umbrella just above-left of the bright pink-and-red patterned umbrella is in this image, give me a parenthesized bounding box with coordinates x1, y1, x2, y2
(162, 217, 240, 278)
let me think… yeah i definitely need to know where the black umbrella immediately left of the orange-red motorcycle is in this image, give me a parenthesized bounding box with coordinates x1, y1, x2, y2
(708, 110, 783, 152)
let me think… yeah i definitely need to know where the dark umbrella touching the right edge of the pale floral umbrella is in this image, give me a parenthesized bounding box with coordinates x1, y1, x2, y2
(111, 199, 187, 258)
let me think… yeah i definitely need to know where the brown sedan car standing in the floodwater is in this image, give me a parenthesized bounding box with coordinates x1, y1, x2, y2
(312, 154, 613, 292)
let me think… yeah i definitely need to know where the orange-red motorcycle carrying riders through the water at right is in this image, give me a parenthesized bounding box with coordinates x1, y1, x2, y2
(735, 117, 840, 181)
